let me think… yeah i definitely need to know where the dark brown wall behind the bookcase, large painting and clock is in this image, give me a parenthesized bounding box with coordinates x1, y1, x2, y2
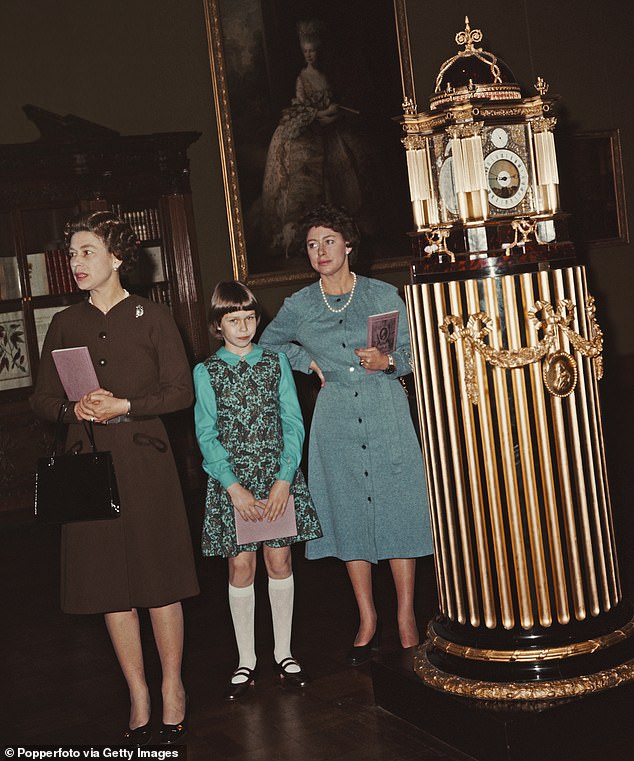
(0, 0, 634, 355)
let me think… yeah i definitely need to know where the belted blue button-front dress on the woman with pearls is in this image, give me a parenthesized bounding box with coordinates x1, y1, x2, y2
(259, 277, 432, 563)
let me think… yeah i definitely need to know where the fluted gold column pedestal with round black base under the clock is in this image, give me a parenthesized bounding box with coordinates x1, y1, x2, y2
(405, 255, 634, 701)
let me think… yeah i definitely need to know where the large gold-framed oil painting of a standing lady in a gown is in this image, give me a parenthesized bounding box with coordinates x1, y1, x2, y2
(205, 0, 413, 285)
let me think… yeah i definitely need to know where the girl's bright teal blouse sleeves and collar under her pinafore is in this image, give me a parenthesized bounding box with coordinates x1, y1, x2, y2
(194, 344, 304, 489)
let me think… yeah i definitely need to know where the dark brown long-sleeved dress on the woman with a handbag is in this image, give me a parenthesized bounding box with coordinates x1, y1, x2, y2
(31, 295, 199, 613)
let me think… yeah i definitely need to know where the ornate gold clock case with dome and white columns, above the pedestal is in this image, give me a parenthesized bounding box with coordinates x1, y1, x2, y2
(403, 18, 563, 254)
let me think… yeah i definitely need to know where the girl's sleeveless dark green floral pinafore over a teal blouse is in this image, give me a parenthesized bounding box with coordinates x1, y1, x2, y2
(202, 351, 322, 557)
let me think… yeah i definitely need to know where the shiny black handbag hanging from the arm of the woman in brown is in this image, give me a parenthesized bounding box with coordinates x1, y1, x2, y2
(35, 404, 120, 523)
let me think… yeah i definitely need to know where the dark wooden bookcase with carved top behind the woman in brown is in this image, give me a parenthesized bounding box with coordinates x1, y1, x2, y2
(0, 106, 209, 522)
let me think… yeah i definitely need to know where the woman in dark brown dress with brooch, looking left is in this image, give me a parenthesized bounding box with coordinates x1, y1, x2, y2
(31, 211, 199, 745)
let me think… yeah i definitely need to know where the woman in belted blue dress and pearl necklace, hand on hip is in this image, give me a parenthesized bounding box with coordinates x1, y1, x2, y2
(260, 205, 432, 666)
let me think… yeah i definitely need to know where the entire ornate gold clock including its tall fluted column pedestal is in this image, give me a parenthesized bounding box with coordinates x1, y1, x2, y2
(396, 19, 634, 724)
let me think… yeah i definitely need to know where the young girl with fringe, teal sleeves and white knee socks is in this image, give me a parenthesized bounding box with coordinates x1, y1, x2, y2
(194, 281, 321, 700)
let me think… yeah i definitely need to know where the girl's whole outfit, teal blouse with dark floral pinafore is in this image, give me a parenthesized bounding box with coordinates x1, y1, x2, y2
(194, 344, 321, 557)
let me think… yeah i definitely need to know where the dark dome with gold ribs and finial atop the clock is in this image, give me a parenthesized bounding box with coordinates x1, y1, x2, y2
(429, 17, 522, 111)
